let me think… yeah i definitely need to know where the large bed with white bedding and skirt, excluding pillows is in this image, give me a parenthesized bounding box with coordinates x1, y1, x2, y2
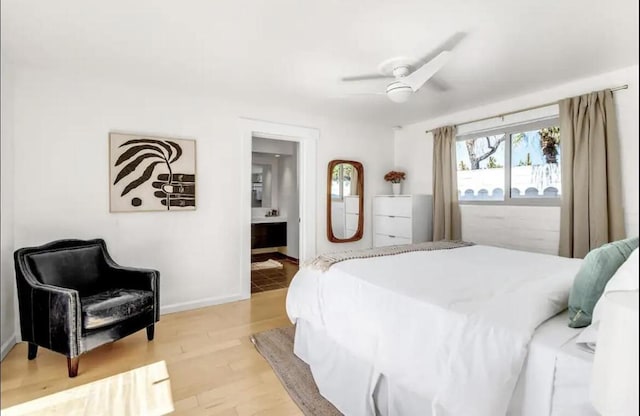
(287, 246, 590, 416)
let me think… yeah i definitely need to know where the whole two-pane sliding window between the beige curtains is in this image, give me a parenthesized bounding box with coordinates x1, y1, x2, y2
(456, 119, 562, 205)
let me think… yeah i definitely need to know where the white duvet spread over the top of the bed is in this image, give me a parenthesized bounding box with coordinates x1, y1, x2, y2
(287, 246, 581, 416)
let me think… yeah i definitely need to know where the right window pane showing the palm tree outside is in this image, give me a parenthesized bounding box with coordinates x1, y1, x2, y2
(511, 126, 562, 198)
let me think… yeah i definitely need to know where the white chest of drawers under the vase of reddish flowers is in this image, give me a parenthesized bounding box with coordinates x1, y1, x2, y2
(373, 195, 433, 247)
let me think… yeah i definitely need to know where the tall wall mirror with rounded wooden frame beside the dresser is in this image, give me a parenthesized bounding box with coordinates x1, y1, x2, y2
(327, 160, 364, 243)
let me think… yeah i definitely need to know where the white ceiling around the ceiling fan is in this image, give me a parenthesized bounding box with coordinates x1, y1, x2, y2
(1, 0, 638, 125)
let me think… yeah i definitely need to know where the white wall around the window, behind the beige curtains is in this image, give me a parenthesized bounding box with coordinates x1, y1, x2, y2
(394, 66, 639, 253)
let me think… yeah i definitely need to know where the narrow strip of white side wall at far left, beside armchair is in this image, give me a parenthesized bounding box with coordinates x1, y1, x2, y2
(0, 56, 16, 359)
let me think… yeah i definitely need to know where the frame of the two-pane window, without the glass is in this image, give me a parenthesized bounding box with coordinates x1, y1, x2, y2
(454, 116, 562, 207)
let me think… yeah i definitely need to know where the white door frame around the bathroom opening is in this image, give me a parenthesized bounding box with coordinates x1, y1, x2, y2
(239, 117, 320, 299)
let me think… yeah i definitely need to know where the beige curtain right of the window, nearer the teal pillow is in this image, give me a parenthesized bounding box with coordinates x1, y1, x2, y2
(560, 90, 625, 258)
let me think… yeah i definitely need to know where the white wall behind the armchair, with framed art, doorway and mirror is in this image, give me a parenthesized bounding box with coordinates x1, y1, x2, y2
(3, 68, 393, 311)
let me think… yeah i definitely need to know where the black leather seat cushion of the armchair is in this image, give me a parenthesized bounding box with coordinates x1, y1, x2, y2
(80, 289, 153, 329)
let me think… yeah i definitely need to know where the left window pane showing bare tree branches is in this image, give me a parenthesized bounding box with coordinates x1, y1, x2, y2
(456, 134, 506, 201)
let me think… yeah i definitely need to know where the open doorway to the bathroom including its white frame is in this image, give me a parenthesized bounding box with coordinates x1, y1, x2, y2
(239, 118, 319, 298)
